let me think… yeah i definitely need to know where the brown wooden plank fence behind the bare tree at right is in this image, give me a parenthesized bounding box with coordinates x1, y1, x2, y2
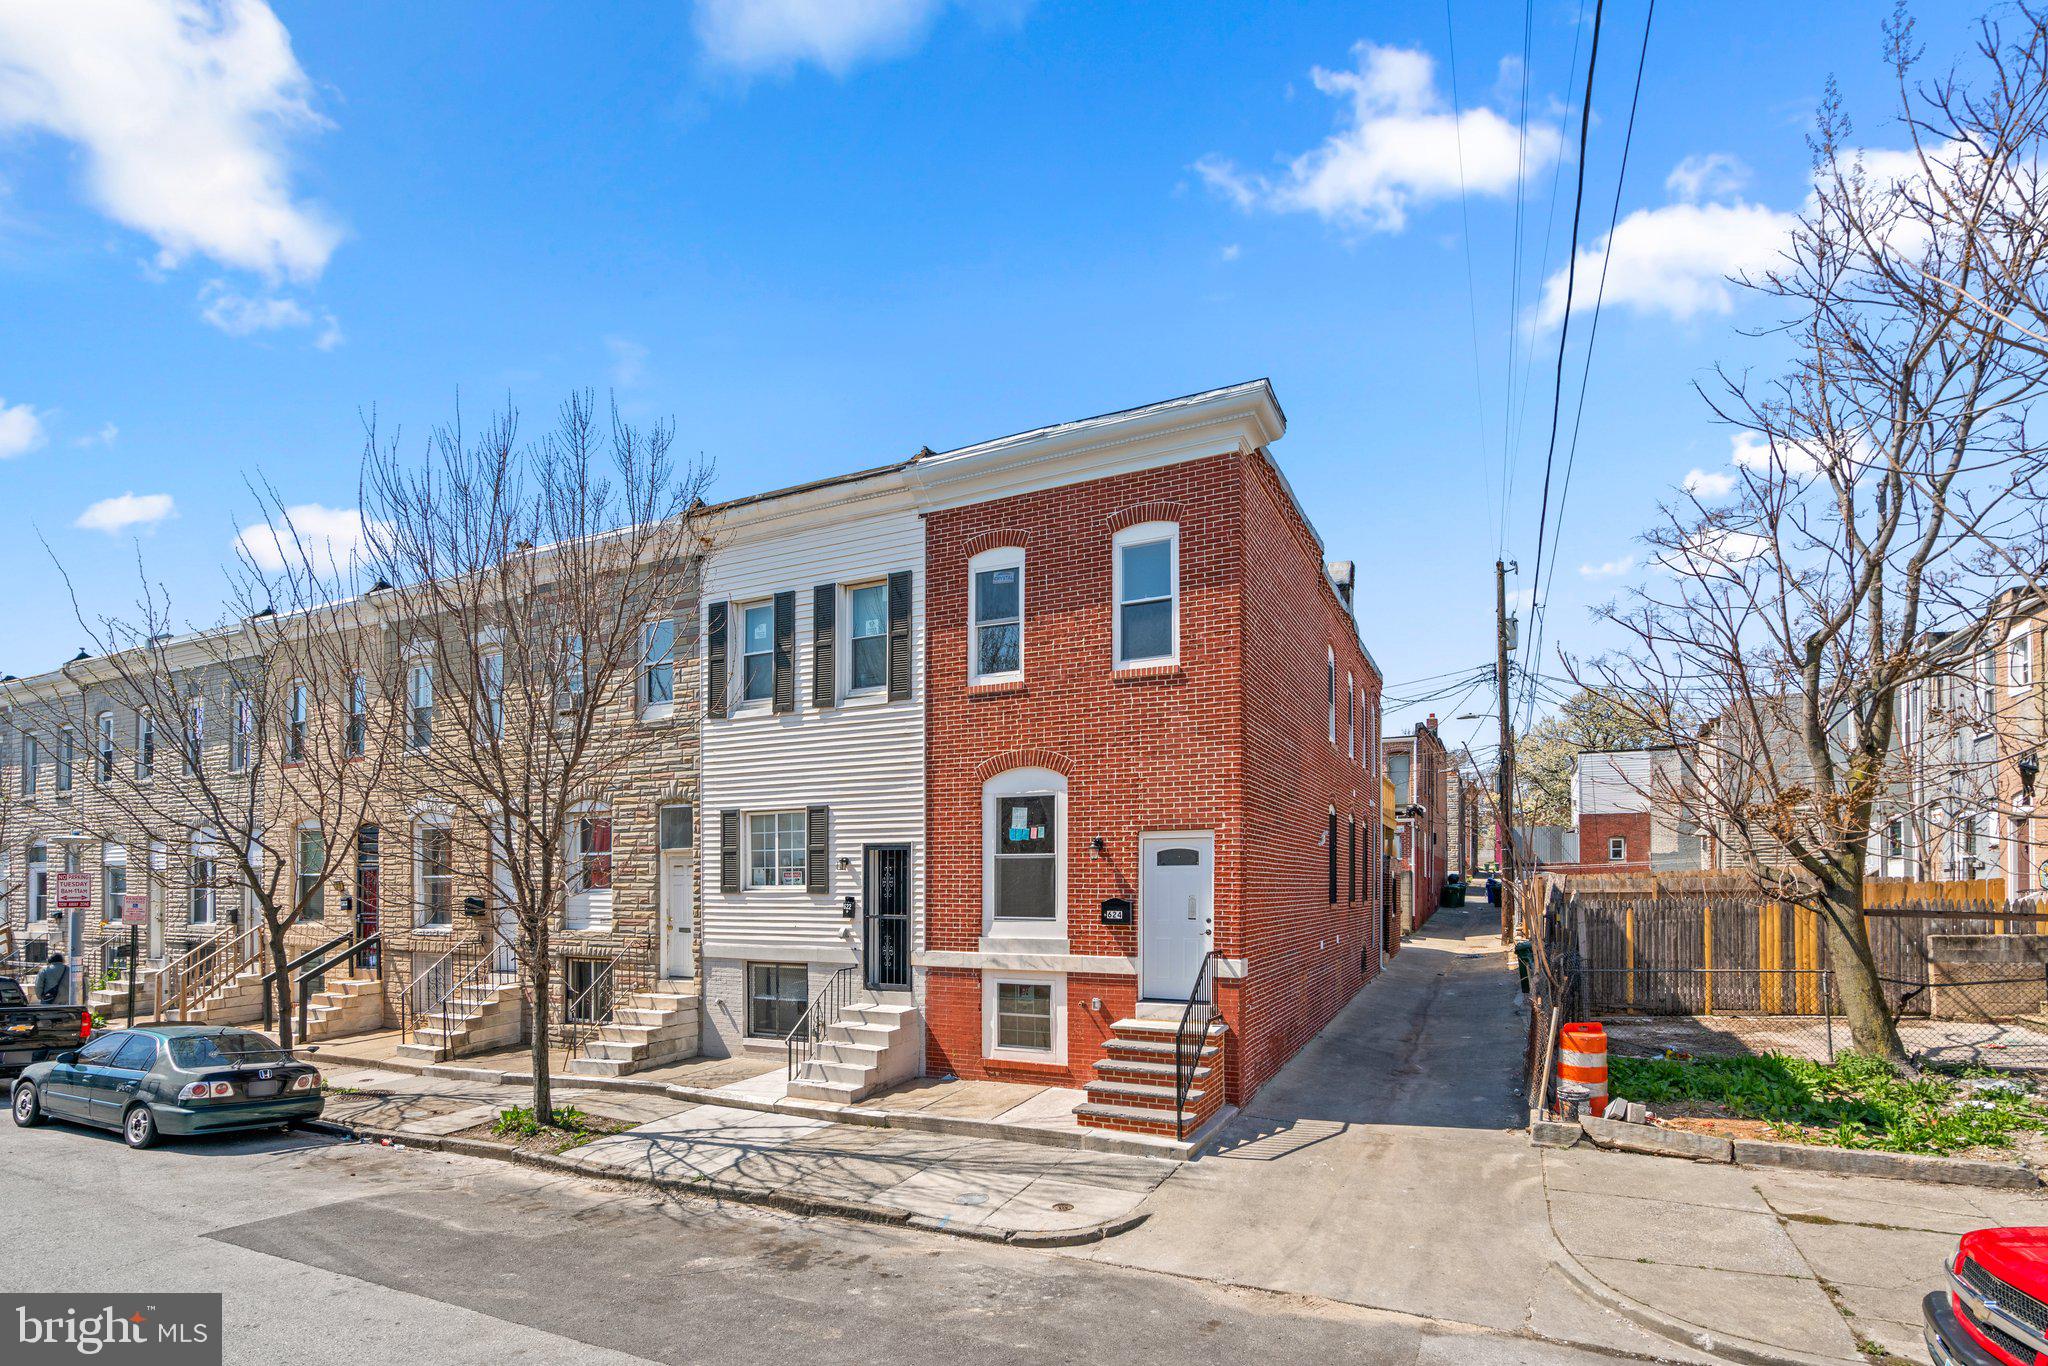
(1544, 879, 2048, 1016)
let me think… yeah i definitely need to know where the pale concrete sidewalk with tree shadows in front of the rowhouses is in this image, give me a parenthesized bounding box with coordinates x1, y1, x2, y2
(313, 1067, 1178, 1245)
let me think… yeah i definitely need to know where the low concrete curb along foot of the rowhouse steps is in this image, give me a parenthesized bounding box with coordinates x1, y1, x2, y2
(326, 1053, 1212, 1161)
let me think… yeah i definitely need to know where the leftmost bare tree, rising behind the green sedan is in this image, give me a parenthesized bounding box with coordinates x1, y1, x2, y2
(41, 497, 393, 1049)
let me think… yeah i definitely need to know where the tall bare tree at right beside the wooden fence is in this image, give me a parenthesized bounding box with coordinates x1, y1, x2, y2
(1587, 8, 2048, 1061)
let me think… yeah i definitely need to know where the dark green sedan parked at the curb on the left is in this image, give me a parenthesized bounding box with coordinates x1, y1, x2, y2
(12, 1024, 326, 1147)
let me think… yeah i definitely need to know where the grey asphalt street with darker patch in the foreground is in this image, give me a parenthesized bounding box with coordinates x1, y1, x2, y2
(0, 1120, 1638, 1366)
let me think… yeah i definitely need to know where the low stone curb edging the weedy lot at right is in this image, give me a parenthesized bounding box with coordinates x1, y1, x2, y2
(1530, 1116, 2042, 1190)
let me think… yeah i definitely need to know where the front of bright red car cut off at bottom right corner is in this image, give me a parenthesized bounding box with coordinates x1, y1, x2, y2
(1921, 1229, 2048, 1366)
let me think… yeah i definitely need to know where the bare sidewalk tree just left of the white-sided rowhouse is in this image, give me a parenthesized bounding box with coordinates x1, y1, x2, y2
(362, 393, 709, 1122)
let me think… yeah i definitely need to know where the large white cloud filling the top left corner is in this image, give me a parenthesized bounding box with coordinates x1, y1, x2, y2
(0, 0, 342, 281)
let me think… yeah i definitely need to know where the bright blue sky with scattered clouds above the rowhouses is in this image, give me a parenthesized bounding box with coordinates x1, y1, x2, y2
(0, 0, 1966, 770)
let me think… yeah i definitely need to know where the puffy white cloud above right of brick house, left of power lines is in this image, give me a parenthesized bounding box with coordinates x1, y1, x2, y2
(1194, 43, 1561, 231)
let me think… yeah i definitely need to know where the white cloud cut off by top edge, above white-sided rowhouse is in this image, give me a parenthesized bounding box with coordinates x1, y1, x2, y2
(696, 0, 1003, 76)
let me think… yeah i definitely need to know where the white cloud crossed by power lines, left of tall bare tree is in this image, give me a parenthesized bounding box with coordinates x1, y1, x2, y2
(1536, 201, 1798, 328)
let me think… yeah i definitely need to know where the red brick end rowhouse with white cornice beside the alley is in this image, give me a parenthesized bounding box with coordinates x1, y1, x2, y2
(911, 381, 1382, 1133)
